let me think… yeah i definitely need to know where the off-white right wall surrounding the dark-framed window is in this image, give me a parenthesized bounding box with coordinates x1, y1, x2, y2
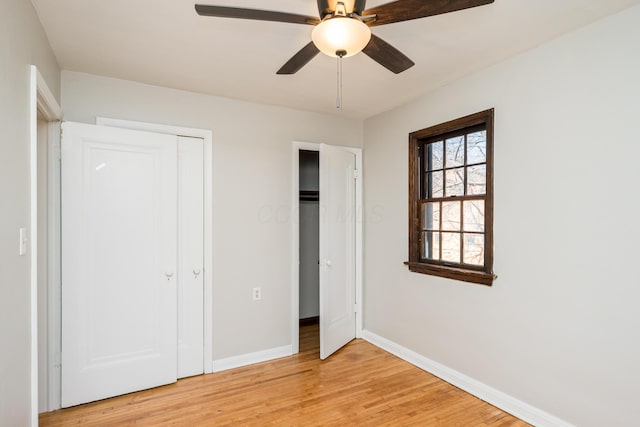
(364, 7, 640, 426)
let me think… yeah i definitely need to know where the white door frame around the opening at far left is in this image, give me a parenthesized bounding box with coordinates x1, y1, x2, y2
(28, 65, 62, 427)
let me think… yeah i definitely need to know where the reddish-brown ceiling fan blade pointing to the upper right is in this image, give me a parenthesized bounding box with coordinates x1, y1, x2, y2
(363, 0, 494, 27)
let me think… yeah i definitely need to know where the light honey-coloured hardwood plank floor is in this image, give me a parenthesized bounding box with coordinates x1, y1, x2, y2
(40, 325, 528, 426)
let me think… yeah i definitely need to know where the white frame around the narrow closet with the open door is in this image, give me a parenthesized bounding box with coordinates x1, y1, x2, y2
(291, 141, 363, 354)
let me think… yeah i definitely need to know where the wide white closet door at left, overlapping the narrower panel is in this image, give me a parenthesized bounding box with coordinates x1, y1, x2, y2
(61, 123, 177, 407)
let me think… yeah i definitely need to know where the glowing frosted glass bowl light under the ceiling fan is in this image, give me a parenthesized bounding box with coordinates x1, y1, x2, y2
(311, 16, 371, 58)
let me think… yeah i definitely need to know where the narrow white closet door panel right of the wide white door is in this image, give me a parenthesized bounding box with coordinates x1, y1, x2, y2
(178, 136, 205, 378)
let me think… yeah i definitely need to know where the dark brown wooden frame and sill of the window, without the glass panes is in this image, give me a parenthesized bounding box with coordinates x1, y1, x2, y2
(406, 109, 496, 286)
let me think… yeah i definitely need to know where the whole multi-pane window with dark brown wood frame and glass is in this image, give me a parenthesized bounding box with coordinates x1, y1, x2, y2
(407, 109, 495, 285)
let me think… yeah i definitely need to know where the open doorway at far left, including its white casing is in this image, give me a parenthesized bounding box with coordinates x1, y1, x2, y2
(29, 65, 62, 426)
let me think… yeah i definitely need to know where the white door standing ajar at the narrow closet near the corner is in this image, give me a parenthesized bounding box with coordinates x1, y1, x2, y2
(320, 144, 356, 359)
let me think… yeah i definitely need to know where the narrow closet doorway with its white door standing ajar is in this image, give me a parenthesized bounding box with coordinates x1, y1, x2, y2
(291, 142, 362, 359)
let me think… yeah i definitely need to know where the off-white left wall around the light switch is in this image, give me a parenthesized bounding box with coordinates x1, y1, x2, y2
(0, 0, 60, 426)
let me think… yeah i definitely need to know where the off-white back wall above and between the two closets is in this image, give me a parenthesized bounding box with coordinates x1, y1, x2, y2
(62, 71, 362, 360)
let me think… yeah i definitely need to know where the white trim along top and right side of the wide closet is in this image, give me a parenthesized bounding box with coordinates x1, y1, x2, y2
(96, 117, 213, 374)
